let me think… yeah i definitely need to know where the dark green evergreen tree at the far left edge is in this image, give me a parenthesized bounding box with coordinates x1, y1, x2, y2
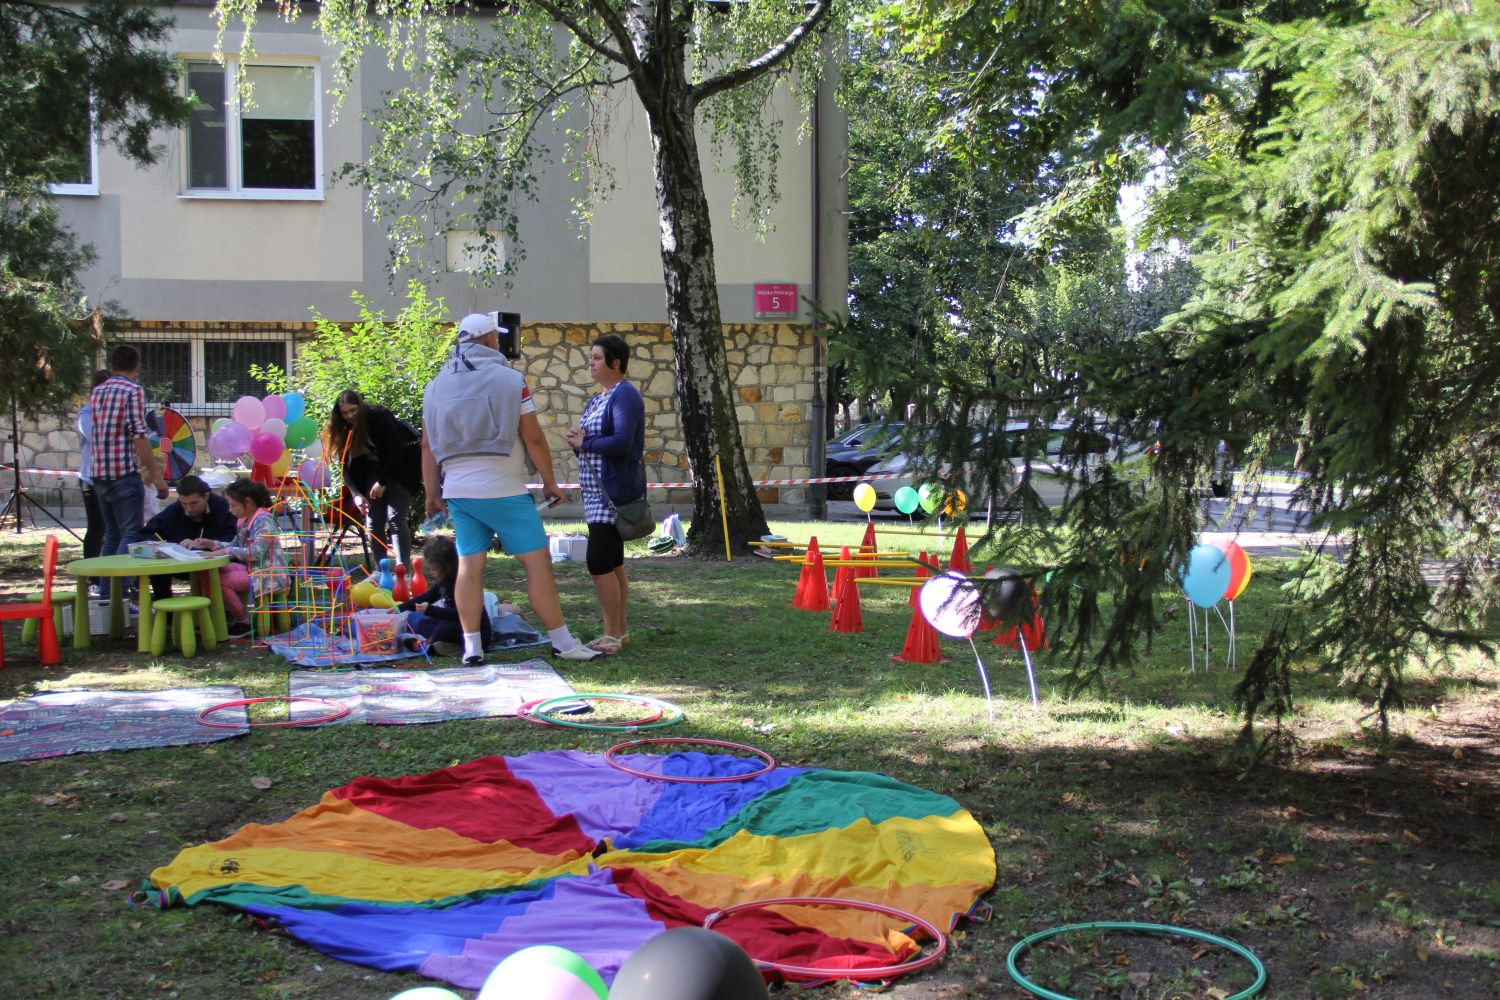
(0, 0, 189, 411)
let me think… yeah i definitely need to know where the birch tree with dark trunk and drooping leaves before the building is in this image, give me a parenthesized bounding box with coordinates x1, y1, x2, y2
(219, 0, 840, 549)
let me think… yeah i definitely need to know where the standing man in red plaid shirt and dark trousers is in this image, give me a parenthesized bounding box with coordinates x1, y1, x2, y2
(89, 343, 167, 556)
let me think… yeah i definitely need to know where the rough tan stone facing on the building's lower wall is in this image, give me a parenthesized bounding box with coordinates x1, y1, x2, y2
(5, 322, 813, 508)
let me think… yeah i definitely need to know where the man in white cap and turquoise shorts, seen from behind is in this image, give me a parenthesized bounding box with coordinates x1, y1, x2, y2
(422, 313, 599, 664)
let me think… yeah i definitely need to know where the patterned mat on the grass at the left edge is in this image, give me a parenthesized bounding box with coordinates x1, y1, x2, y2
(0, 687, 251, 762)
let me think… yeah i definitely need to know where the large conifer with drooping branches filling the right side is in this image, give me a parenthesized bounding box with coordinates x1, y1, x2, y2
(858, 0, 1500, 750)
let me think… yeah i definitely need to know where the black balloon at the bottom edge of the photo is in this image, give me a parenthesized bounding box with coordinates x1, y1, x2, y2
(609, 927, 770, 1000)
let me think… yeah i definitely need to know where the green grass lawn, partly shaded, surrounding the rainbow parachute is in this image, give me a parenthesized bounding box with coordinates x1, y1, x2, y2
(0, 522, 1500, 1000)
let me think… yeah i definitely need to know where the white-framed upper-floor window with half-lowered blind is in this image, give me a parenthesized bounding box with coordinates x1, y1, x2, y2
(185, 58, 323, 199)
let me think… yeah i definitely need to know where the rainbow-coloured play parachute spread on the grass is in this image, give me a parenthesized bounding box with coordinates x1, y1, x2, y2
(150, 751, 995, 990)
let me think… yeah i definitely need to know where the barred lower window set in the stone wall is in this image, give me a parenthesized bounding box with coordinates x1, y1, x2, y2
(125, 334, 293, 417)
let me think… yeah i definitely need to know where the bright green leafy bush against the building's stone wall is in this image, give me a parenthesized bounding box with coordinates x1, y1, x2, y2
(251, 280, 453, 427)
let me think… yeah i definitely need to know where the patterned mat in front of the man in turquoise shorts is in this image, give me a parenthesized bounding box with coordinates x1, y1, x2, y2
(290, 660, 573, 726)
